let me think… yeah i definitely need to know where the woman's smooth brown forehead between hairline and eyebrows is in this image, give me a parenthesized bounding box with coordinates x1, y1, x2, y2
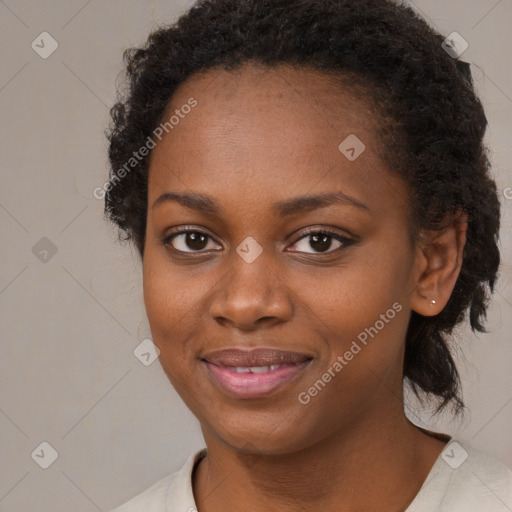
(149, 64, 408, 215)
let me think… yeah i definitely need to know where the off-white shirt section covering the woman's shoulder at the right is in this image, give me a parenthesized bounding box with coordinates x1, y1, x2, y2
(407, 439, 512, 512)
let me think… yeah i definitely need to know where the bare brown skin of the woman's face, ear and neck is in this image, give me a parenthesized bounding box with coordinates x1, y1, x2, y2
(143, 64, 466, 512)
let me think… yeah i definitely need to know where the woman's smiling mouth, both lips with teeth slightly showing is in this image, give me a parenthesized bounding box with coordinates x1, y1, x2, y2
(201, 348, 312, 399)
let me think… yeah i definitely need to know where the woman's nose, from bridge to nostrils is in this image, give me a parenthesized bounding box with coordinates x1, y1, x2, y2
(209, 246, 293, 330)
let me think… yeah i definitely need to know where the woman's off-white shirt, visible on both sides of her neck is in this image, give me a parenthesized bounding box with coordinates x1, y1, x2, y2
(111, 439, 512, 512)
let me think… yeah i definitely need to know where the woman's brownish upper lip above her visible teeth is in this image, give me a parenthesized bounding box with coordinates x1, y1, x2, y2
(202, 347, 312, 367)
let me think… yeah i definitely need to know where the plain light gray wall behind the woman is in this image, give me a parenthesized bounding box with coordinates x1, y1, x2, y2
(0, 0, 512, 512)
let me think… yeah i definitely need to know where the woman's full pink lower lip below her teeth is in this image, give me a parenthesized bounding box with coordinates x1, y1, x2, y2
(204, 360, 311, 398)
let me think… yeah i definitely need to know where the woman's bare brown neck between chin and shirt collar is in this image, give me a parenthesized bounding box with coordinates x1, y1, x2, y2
(193, 408, 445, 512)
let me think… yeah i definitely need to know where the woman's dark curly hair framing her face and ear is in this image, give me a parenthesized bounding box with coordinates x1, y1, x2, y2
(105, 0, 500, 413)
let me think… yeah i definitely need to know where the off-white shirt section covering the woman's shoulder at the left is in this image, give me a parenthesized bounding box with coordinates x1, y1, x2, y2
(110, 449, 205, 512)
